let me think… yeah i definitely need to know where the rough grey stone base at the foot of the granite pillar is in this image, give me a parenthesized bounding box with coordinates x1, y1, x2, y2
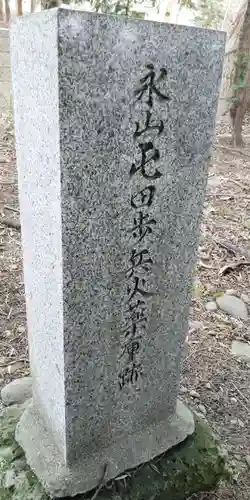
(16, 401, 194, 498)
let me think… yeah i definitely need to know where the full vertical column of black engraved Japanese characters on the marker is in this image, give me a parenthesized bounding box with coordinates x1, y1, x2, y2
(118, 63, 171, 390)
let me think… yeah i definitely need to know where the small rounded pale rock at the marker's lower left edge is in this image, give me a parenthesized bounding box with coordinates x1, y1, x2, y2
(1, 377, 32, 406)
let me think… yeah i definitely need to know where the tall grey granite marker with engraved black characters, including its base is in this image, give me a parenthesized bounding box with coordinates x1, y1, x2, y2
(11, 9, 225, 496)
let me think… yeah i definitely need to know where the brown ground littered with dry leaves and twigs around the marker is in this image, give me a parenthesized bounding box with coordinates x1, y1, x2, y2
(0, 114, 250, 500)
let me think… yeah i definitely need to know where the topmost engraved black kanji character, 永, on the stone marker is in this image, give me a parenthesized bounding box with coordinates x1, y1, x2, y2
(135, 64, 170, 108)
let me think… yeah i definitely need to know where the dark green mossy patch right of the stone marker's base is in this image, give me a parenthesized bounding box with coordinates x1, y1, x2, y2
(85, 419, 229, 500)
